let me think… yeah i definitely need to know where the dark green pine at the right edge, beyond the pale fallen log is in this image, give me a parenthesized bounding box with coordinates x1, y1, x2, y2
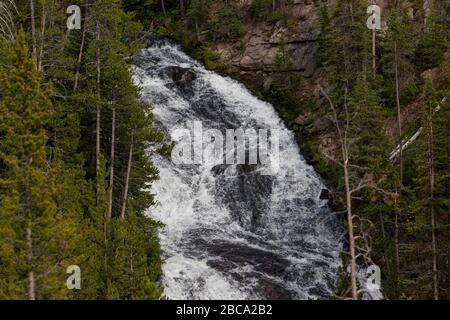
(409, 79, 450, 300)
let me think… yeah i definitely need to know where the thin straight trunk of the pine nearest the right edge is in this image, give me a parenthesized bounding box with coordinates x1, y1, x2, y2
(428, 117, 439, 300)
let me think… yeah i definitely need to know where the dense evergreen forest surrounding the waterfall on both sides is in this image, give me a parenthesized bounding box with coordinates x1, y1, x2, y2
(0, 0, 450, 300)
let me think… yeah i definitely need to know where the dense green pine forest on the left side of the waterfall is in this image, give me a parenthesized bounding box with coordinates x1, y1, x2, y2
(0, 0, 164, 299)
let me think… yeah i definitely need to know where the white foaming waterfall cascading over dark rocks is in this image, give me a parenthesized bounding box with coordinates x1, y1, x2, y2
(134, 40, 342, 299)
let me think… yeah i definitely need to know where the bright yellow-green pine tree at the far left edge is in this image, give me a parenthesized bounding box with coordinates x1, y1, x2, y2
(0, 32, 79, 300)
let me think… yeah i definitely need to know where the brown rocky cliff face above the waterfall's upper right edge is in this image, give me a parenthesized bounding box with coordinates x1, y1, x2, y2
(214, 0, 320, 92)
